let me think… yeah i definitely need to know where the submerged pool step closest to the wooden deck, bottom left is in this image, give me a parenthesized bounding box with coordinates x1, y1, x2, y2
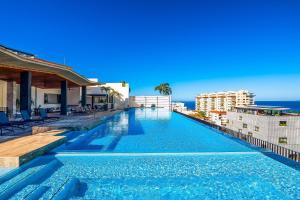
(0, 160, 59, 199)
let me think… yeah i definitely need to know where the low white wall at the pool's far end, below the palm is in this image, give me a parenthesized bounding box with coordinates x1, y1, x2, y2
(129, 96, 172, 109)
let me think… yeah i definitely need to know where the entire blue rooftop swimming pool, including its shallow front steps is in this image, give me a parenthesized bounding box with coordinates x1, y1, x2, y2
(0, 109, 300, 199)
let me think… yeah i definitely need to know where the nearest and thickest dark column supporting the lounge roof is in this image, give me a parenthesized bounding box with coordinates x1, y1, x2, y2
(20, 71, 32, 115)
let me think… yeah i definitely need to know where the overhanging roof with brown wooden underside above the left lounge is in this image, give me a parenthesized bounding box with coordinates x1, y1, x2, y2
(0, 45, 100, 88)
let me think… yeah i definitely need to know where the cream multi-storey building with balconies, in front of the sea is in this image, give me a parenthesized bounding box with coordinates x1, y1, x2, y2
(195, 90, 254, 117)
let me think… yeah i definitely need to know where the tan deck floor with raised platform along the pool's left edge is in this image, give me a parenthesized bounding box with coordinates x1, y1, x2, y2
(0, 111, 120, 167)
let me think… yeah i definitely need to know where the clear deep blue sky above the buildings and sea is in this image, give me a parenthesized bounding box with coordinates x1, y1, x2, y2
(0, 0, 300, 100)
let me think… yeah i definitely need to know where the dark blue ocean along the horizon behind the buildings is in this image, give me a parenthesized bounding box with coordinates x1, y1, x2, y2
(181, 101, 300, 112)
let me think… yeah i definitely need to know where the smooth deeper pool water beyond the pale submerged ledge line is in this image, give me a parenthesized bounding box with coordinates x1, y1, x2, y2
(55, 109, 253, 153)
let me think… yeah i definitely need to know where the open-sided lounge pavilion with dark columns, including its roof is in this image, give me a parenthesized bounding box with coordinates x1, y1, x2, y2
(0, 45, 99, 136)
